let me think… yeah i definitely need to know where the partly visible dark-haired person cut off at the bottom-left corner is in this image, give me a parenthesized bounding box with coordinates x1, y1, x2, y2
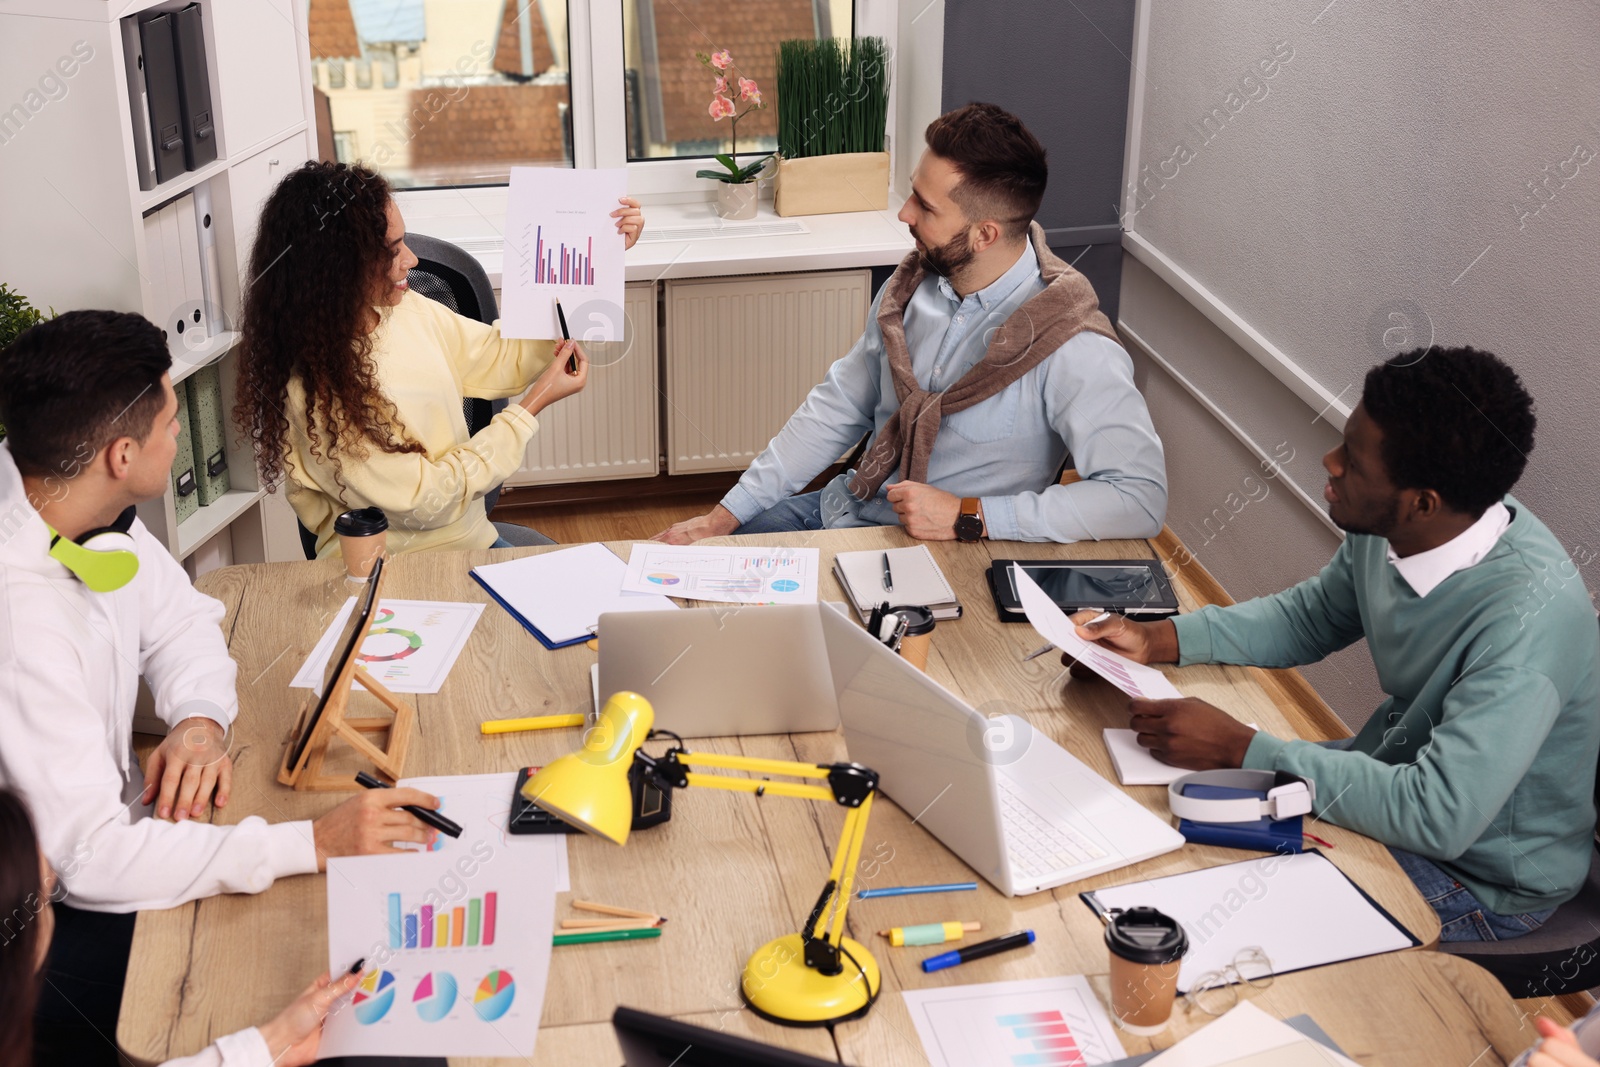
(0, 789, 362, 1067)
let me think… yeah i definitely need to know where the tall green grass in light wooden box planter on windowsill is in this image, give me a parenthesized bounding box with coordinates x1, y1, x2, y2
(773, 37, 890, 214)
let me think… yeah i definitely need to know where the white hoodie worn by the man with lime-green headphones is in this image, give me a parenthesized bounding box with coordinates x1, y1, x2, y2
(0, 443, 317, 912)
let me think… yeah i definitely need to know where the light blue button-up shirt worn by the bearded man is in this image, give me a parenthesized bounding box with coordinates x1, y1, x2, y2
(722, 245, 1166, 542)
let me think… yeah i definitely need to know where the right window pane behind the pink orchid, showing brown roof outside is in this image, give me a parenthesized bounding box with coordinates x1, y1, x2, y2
(622, 0, 854, 160)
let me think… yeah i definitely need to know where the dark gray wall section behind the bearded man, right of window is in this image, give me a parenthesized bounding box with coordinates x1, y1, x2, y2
(944, 0, 1133, 318)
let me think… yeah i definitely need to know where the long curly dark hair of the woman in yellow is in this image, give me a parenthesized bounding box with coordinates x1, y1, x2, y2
(234, 160, 424, 486)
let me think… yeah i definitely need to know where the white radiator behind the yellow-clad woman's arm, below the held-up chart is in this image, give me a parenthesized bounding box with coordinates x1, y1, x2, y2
(506, 282, 661, 485)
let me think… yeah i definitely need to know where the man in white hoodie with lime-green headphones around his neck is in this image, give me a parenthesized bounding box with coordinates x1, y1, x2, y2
(0, 312, 438, 1064)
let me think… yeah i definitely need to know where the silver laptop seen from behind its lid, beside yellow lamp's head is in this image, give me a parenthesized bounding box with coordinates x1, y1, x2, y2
(595, 605, 844, 737)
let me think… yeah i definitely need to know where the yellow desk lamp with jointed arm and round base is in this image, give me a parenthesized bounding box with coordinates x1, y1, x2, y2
(522, 693, 883, 1025)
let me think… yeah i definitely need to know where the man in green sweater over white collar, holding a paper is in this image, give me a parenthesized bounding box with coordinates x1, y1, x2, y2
(1078, 349, 1600, 941)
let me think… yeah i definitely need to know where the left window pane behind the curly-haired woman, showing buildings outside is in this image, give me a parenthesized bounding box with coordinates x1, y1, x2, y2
(309, 0, 573, 189)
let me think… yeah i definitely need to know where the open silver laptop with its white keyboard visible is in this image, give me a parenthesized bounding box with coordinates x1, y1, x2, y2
(819, 605, 1184, 896)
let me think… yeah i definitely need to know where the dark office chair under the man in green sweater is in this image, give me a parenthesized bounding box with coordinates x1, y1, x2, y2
(1438, 617, 1600, 997)
